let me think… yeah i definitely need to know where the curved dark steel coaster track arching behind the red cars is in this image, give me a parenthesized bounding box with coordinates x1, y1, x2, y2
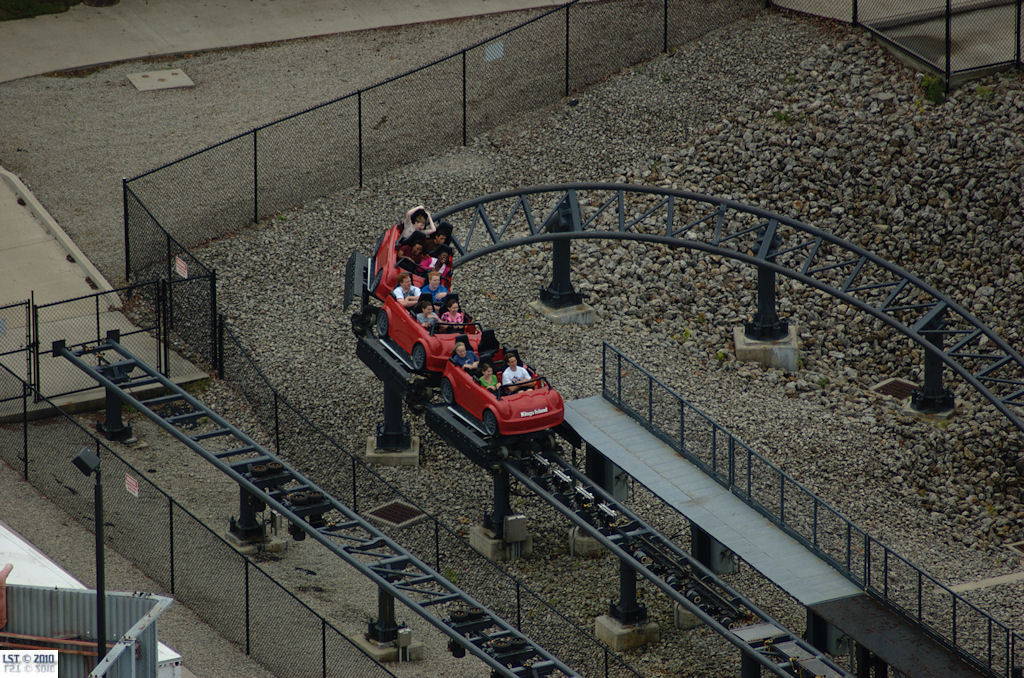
(434, 183, 1024, 440)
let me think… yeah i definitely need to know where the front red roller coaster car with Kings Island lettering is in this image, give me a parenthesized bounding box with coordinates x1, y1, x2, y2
(441, 353, 565, 436)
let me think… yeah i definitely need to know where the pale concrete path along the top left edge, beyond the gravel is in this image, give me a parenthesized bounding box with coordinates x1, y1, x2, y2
(0, 0, 561, 82)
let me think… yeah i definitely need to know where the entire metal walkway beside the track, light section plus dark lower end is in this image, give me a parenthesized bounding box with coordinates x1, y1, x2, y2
(565, 395, 985, 678)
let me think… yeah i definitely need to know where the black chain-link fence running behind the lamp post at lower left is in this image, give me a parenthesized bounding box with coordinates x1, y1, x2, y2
(0, 366, 393, 678)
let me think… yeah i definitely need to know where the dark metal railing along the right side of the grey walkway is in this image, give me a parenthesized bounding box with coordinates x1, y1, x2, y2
(601, 343, 1024, 678)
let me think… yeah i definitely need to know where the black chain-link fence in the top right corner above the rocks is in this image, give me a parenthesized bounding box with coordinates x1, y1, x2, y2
(771, 0, 1022, 88)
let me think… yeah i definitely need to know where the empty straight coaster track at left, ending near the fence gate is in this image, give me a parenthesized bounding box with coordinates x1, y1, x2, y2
(53, 338, 579, 677)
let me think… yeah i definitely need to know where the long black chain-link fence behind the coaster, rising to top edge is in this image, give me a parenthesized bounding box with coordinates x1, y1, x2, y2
(122, 0, 764, 280)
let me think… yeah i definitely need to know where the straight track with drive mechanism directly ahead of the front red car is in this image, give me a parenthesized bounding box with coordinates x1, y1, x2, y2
(426, 406, 850, 678)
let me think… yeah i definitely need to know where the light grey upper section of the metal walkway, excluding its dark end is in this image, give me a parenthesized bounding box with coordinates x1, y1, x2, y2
(565, 395, 862, 606)
